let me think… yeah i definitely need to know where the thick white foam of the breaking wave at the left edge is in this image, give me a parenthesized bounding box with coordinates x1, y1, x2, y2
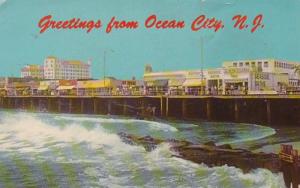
(0, 114, 144, 152)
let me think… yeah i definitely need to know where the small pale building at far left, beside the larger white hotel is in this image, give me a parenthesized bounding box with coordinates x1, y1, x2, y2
(21, 65, 44, 79)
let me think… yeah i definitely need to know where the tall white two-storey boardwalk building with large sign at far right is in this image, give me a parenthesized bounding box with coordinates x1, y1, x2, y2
(223, 59, 300, 94)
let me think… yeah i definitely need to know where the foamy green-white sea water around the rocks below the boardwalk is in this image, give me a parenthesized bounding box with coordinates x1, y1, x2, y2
(0, 111, 284, 188)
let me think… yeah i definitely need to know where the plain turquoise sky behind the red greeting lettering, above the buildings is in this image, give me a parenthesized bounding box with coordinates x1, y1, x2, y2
(0, 0, 300, 79)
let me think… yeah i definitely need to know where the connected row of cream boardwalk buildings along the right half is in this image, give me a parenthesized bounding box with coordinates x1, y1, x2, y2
(144, 59, 300, 95)
